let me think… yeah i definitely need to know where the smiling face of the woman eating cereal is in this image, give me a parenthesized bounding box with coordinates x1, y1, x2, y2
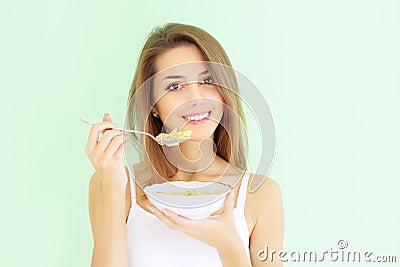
(153, 45, 224, 140)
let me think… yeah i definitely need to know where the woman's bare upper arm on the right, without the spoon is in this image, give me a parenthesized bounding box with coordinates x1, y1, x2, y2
(250, 178, 284, 267)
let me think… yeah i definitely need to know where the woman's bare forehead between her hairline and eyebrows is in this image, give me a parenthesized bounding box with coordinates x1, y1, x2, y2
(155, 45, 205, 73)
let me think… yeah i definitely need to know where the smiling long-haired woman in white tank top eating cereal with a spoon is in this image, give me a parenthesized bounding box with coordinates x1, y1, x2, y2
(86, 24, 283, 267)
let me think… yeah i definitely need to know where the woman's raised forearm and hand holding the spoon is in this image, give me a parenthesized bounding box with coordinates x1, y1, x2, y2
(85, 114, 128, 267)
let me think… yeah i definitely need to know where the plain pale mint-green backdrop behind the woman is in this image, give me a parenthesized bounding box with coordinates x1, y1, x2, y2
(0, 0, 400, 267)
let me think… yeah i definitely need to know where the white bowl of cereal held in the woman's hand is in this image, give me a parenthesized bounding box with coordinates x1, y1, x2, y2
(143, 181, 232, 220)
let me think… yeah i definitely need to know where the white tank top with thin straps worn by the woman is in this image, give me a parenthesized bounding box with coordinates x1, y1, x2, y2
(126, 173, 250, 267)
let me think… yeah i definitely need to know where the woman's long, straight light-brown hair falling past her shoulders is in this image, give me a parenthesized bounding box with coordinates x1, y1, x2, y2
(126, 23, 246, 185)
